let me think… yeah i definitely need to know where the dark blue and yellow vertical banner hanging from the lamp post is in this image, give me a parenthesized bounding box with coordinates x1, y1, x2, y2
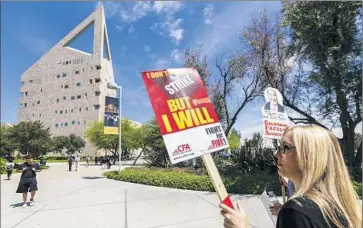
(104, 97, 120, 135)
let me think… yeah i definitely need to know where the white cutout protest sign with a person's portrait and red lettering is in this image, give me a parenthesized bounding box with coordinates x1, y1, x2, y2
(262, 87, 289, 139)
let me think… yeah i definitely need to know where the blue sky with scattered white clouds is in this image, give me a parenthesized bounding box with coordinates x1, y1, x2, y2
(1, 1, 362, 138)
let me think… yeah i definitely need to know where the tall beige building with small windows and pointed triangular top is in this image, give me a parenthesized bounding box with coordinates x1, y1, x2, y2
(19, 5, 116, 156)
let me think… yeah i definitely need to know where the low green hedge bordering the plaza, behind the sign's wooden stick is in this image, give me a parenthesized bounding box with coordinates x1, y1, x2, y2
(104, 168, 281, 194)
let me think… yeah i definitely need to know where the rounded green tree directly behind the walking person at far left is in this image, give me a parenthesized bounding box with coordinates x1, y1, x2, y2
(9, 121, 52, 157)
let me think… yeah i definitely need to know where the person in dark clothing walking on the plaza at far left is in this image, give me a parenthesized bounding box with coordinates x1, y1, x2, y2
(16, 155, 40, 207)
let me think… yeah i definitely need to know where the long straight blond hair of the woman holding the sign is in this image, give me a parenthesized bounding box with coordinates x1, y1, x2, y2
(284, 124, 362, 228)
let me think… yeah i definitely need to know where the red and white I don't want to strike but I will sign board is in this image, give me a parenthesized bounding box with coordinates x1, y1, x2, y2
(142, 68, 229, 164)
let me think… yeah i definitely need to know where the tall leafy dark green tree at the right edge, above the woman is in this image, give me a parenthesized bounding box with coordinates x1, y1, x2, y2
(284, 1, 362, 165)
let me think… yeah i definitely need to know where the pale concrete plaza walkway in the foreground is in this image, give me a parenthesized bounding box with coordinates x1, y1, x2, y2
(1, 163, 273, 228)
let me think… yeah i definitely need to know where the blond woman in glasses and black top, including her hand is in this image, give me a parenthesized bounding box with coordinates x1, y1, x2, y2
(220, 125, 362, 228)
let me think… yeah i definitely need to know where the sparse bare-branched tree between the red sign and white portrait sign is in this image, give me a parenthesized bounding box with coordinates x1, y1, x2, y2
(184, 46, 265, 136)
